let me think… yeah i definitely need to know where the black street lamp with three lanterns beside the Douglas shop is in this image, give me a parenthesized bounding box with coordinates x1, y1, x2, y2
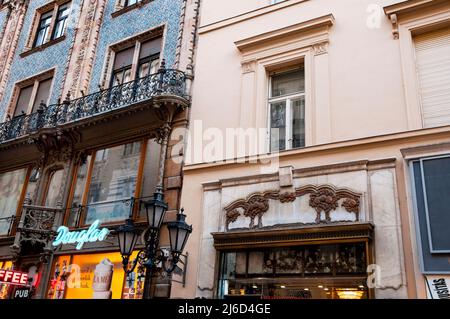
(117, 189, 192, 299)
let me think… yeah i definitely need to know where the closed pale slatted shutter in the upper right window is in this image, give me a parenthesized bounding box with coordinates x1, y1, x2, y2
(414, 28, 450, 127)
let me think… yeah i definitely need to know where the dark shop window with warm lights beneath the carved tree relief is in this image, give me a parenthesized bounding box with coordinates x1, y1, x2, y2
(219, 243, 369, 299)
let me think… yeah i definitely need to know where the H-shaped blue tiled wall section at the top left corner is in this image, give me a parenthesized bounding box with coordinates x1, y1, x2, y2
(0, 0, 82, 119)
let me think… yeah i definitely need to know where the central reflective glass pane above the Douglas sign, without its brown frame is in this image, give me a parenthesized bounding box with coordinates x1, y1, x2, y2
(85, 145, 140, 224)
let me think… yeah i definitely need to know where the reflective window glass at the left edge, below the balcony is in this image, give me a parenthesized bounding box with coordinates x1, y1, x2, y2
(0, 168, 27, 236)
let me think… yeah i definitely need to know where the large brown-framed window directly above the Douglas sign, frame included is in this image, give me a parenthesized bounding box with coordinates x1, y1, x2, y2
(67, 140, 160, 227)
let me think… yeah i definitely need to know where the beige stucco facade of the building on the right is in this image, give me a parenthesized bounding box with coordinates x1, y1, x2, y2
(172, 0, 450, 298)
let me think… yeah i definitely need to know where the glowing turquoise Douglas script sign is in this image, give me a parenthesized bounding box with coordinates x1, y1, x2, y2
(53, 220, 109, 250)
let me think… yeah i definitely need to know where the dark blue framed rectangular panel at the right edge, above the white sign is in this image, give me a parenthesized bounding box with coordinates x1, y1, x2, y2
(411, 155, 450, 273)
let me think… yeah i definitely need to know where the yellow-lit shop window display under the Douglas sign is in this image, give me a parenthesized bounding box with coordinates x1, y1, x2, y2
(47, 253, 145, 299)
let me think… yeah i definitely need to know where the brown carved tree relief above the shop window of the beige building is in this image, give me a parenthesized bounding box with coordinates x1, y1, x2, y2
(224, 185, 362, 230)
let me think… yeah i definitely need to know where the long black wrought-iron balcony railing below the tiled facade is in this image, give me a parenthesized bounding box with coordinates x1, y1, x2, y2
(0, 64, 188, 143)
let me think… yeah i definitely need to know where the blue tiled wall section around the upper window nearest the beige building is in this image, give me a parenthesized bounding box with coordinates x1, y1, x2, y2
(90, 0, 183, 92)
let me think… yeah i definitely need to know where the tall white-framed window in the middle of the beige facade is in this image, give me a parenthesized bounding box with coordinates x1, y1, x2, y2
(268, 67, 305, 152)
